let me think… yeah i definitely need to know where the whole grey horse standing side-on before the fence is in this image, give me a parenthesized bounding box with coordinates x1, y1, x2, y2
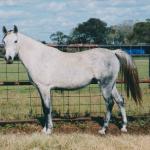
(3, 26, 142, 134)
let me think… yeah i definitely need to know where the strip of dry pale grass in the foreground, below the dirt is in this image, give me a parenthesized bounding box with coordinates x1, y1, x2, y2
(0, 133, 150, 150)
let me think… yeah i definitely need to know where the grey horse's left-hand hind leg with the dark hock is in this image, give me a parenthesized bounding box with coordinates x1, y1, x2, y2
(98, 84, 114, 134)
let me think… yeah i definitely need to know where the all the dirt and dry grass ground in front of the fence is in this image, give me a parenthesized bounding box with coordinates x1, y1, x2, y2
(0, 118, 150, 150)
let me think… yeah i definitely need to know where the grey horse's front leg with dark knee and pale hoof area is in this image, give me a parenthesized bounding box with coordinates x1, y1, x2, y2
(38, 86, 53, 134)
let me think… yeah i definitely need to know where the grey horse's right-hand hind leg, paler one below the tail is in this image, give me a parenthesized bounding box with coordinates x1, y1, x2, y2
(112, 85, 127, 132)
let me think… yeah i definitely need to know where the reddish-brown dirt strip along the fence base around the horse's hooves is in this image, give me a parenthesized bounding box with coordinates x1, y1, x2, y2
(0, 118, 150, 135)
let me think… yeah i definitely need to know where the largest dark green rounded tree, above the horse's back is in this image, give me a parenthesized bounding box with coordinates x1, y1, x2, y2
(68, 18, 107, 44)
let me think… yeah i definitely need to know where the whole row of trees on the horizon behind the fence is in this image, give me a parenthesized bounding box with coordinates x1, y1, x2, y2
(50, 18, 150, 45)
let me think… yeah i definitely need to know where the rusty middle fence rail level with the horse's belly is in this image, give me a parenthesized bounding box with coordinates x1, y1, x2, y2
(0, 79, 150, 86)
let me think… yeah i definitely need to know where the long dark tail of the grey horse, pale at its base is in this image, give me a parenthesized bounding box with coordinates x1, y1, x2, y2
(114, 49, 142, 104)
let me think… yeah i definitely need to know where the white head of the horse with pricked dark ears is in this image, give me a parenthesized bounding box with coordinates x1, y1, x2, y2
(3, 25, 18, 64)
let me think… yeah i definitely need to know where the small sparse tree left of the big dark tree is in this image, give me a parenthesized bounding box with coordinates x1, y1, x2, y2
(50, 31, 68, 45)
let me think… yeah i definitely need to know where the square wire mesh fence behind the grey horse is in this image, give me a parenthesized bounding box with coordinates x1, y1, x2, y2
(0, 46, 150, 120)
